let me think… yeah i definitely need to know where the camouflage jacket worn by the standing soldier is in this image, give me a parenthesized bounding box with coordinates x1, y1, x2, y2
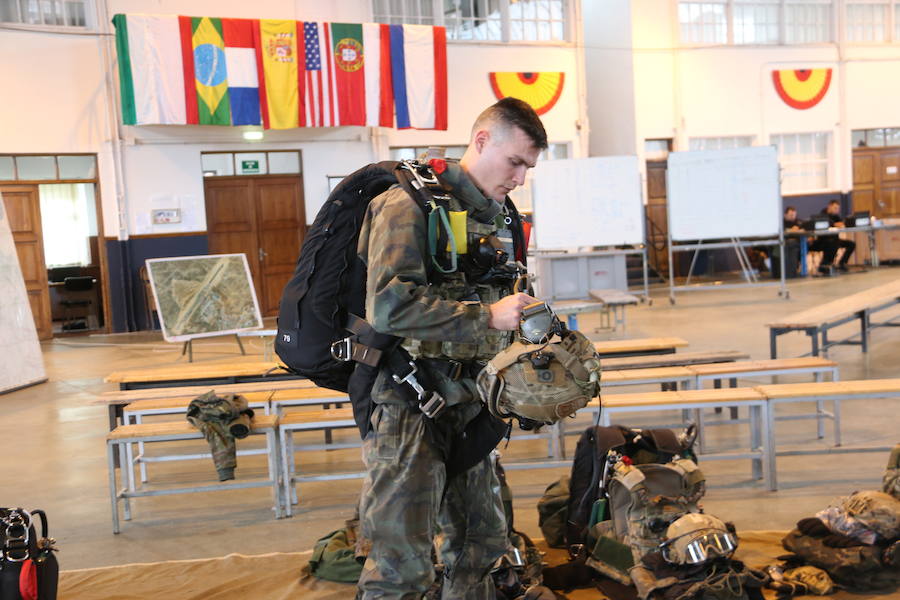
(358, 169, 512, 405)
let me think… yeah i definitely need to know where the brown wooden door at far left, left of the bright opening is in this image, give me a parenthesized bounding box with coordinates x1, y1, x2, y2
(0, 185, 53, 340)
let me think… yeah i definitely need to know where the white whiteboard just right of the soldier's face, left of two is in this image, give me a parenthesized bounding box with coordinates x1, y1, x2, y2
(531, 156, 644, 250)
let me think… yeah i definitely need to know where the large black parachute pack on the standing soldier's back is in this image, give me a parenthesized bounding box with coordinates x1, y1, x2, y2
(275, 161, 398, 392)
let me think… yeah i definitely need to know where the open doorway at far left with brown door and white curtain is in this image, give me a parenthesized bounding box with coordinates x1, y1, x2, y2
(0, 155, 109, 340)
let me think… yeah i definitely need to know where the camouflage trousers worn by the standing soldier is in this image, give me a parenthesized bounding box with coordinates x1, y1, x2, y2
(357, 404, 507, 600)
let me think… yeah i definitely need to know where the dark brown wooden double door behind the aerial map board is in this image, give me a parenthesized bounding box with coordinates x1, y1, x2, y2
(204, 176, 306, 316)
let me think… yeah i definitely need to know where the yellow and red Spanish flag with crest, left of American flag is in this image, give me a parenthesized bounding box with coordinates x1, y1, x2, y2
(256, 19, 300, 129)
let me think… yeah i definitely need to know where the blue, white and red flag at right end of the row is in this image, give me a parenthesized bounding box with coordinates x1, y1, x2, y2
(390, 25, 447, 130)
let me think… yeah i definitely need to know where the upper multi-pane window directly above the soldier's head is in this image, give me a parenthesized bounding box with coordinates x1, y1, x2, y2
(372, 0, 568, 42)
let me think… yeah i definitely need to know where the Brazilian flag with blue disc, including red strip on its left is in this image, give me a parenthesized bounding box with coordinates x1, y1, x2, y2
(178, 17, 231, 125)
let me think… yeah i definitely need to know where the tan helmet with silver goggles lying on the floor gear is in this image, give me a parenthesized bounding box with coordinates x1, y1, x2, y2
(659, 513, 738, 565)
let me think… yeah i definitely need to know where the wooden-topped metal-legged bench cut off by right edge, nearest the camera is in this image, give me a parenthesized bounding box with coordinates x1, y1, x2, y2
(754, 379, 900, 490)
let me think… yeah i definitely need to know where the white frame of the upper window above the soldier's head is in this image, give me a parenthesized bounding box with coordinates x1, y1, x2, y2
(370, 0, 575, 46)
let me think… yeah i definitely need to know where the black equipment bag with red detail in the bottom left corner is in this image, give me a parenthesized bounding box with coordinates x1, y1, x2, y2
(0, 508, 59, 600)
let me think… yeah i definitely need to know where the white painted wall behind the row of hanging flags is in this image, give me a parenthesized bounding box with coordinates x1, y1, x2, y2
(0, 0, 581, 237)
